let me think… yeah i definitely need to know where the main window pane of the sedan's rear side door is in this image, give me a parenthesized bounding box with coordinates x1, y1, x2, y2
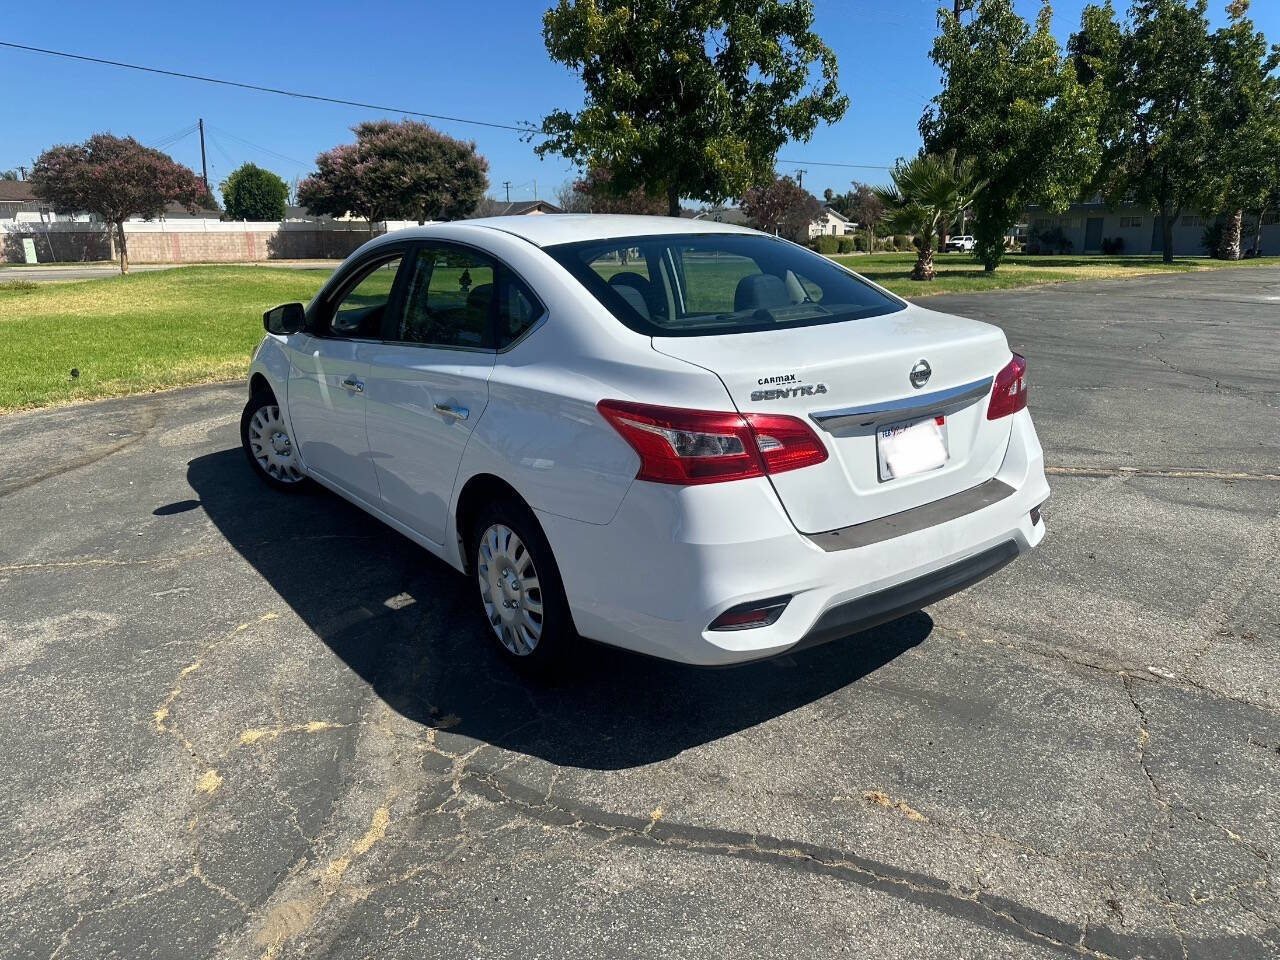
(397, 244, 497, 348)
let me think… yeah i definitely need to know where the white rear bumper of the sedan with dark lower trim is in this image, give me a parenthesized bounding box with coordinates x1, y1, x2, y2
(539, 411, 1050, 666)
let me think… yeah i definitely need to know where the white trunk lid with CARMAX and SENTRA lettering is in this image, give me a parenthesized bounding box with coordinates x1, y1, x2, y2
(653, 305, 1010, 534)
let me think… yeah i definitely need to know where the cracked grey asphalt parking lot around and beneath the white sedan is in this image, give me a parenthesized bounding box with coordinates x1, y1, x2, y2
(0, 269, 1280, 959)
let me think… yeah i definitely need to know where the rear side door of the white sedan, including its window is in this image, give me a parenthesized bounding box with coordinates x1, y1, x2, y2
(365, 241, 542, 544)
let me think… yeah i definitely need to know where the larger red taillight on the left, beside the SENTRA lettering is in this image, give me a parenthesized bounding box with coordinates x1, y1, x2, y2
(595, 401, 827, 484)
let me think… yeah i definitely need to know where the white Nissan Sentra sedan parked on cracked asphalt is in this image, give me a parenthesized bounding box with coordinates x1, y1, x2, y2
(242, 215, 1050, 664)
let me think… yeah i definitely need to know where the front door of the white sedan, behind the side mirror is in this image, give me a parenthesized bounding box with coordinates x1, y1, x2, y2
(288, 251, 403, 506)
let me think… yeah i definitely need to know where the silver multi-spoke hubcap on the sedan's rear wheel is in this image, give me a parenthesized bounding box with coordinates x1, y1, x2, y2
(476, 524, 543, 657)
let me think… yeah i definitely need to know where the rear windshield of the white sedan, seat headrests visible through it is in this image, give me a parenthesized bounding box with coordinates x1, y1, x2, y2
(547, 233, 905, 337)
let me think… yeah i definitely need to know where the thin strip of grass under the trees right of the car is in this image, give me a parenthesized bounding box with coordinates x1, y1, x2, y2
(832, 253, 1280, 297)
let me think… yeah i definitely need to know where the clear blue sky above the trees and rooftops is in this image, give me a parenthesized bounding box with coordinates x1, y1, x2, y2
(0, 0, 1280, 200)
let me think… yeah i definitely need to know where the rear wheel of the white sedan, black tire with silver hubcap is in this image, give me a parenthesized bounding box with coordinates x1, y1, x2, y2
(467, 499, 577, 672)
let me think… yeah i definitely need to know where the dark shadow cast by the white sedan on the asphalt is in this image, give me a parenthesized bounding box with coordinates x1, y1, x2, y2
(187, 448, 933, 769)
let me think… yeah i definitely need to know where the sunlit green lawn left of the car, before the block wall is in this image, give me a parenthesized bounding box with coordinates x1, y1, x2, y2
(0, 266, 330, 411)
